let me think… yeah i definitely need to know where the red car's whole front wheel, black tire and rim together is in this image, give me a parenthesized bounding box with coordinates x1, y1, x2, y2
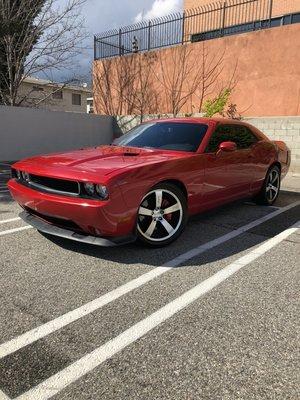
(136, 183, 188, 247)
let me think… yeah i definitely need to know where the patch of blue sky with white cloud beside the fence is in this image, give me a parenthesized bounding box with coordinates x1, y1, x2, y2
(47, 0, 182, 80)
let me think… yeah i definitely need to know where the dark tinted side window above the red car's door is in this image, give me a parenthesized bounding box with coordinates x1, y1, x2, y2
(206, 125, 258, 153)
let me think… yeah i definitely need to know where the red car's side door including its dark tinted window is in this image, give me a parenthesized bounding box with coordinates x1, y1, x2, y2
(204, 124, 258, 205)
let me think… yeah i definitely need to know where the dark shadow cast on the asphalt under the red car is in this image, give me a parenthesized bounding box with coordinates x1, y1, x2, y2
(43, 197, 300, 267)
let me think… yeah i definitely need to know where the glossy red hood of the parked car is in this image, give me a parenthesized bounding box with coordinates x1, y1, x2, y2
(14, 146, 190, 179)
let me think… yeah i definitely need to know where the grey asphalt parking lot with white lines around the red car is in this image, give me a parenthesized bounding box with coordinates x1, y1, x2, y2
(0, 165, 300, 400)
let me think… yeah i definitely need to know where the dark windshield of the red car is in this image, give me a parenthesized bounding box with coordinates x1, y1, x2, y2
(113, 122, 208, 152)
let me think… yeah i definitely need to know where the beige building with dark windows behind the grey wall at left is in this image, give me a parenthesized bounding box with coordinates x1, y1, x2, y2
(19, 77, 92, 113)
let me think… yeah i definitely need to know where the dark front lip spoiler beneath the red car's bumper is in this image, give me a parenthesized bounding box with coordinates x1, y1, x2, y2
(19, 211, 136, 247)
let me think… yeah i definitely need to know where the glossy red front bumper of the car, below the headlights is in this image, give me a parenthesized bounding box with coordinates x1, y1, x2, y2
(8, 179, 135, 238)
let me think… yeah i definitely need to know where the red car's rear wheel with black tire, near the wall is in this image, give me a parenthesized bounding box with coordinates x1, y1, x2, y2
(254, 165, 281, 206)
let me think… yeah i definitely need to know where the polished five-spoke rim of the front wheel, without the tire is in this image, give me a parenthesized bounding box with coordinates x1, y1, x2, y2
(137, 188, 183, 242)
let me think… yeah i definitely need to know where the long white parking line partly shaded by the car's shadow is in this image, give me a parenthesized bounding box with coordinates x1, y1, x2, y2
(0, 201, 300, 359)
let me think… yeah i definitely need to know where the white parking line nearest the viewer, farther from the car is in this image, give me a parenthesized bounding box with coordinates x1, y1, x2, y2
(16, 221, 300, 400)
